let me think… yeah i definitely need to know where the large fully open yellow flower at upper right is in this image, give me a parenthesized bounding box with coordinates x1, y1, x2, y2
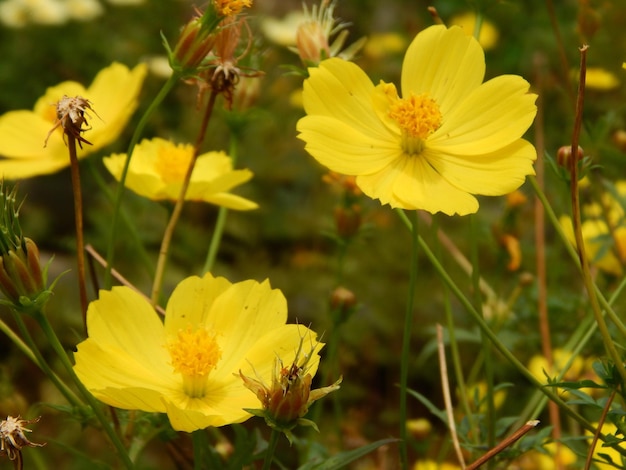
(298, 25, 537, 215)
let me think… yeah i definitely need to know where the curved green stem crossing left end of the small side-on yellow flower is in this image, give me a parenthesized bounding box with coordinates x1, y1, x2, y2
(104, 72, 182, 289)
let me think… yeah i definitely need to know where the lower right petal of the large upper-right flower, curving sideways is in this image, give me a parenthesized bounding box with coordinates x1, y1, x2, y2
(421, 139, 537, 196)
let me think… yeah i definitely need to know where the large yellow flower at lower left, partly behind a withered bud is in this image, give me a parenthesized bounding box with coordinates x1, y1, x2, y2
(74, 274, 323, 432)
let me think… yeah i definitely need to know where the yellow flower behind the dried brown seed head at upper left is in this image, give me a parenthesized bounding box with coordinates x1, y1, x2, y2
(0, 63, 147, 179)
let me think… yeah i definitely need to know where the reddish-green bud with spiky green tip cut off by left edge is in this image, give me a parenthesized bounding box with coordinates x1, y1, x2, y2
(0, 184, 51, 313)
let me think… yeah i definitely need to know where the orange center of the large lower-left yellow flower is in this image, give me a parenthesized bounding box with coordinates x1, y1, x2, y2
(167, 327, 222, 398)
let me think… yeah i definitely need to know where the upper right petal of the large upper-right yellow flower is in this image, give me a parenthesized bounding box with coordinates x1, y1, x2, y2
(427, 75, 537, 155)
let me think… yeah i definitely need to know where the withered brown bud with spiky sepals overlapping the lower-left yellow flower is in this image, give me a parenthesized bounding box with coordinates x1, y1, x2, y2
(239, 334, 342, 442)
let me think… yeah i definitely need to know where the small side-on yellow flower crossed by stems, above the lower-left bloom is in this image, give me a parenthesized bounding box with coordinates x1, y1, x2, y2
(104, 138, 258, 210)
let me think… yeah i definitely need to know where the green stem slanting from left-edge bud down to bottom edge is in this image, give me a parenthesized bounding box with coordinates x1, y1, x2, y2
(33, 311, 135, 470)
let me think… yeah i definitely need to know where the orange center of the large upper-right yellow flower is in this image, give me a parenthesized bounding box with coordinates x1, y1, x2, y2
(389, 93, 442, 155)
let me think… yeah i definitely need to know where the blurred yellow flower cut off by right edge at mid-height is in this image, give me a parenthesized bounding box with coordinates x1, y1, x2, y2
(559, 181, 626, 276)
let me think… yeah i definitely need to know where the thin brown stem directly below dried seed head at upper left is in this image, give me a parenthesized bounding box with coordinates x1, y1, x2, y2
(65, 132, 88, 329)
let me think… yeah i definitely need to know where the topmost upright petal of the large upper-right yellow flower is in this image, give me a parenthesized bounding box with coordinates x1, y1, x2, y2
(402, 25, 485, 116)
